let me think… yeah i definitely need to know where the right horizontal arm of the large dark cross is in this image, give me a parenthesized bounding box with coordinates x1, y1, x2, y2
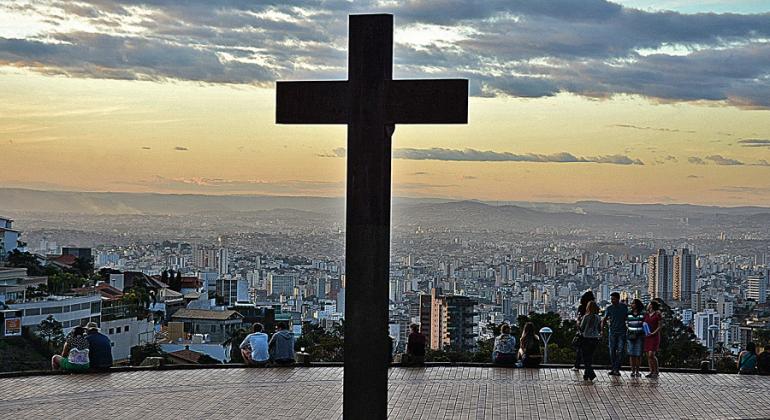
(387, 79, 468, 124)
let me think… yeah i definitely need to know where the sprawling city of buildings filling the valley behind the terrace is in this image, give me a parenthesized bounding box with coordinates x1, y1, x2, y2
(0, 192, 770, 370)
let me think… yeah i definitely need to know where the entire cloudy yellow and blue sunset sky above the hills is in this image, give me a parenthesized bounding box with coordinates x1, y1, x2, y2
(0, 0, 770, 206)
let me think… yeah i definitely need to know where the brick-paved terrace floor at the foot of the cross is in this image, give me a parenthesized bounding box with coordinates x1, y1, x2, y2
(0, 367, 770, 419)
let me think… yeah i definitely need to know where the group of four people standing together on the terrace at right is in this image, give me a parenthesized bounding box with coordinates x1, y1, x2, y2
(573, 290, 663, 381)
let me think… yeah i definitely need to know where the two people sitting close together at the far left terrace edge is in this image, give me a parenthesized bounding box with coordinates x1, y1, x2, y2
(51, 322, 112, 372)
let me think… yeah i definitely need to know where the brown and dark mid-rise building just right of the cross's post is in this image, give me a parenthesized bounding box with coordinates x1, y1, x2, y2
(420, 288, 478, 351)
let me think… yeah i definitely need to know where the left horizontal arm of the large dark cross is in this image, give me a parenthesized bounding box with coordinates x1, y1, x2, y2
(275, 80, 350, 124)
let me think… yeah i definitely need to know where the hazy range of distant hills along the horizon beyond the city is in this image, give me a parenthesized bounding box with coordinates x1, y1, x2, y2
(0, 188, 770, 232)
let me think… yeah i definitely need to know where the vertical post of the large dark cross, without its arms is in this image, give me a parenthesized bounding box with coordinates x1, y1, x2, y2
(343, 15, 393, 419)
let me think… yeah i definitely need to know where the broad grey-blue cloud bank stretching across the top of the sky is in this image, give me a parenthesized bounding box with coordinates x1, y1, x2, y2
(0, 0, 770, 106)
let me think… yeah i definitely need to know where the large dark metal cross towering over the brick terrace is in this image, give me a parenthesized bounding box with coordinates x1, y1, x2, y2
(276, 14, 468, 419)
